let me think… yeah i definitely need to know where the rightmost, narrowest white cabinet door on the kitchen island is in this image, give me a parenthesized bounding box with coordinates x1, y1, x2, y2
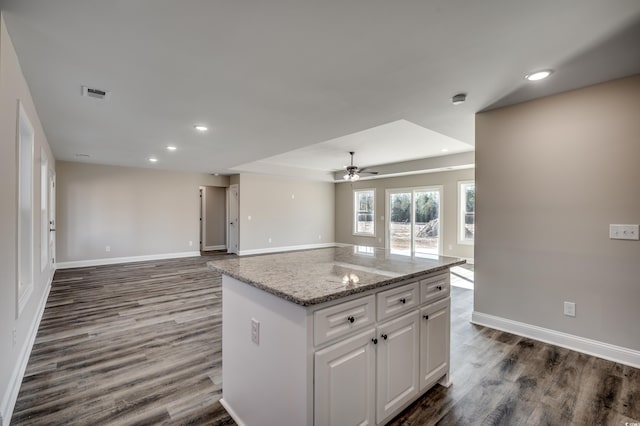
(420, 297, 451, 391)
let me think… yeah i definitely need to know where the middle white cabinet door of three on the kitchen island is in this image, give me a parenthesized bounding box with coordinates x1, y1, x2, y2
(376, 309, 420, 423)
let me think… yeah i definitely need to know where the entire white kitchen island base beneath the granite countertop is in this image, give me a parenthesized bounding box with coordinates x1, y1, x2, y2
(221, 271, 450, 426)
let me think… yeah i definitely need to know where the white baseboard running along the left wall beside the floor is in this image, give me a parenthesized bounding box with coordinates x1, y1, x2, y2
(0, 281, 51, 426)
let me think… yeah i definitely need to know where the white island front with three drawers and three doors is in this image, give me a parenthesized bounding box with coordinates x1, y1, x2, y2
(314, 271, 450, 426)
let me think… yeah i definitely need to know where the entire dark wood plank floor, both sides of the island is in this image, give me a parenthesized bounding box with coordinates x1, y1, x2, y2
(11, 257, 640, 426)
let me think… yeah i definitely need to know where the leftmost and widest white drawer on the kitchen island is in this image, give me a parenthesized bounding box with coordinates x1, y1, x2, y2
(313, 295, 376, 346)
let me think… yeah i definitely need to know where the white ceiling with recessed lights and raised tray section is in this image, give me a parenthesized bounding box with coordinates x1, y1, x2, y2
(0, 0, 640, 178)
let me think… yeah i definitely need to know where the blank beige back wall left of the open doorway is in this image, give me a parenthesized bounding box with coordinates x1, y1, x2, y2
(57, 161, 228, 262)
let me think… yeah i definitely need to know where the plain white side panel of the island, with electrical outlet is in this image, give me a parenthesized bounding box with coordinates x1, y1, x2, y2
(222, 275, 313, 426)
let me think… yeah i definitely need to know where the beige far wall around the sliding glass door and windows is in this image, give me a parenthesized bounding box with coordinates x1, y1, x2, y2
(335, 169, 475, 259)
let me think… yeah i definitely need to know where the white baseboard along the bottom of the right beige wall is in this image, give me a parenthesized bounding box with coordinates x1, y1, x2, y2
(471, 311, 640, 368)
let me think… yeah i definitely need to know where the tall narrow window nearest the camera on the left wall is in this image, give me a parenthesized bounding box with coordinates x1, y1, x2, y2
(17, 103, 34, 315)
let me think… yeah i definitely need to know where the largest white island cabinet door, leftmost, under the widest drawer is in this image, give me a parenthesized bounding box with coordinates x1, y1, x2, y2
(314, 328, 376, 426)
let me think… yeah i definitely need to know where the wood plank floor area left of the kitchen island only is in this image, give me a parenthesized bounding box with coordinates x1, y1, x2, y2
(11, 255, 234, 425)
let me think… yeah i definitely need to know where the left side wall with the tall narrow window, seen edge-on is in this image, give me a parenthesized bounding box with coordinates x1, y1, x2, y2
(0, 13, 56, 424)
